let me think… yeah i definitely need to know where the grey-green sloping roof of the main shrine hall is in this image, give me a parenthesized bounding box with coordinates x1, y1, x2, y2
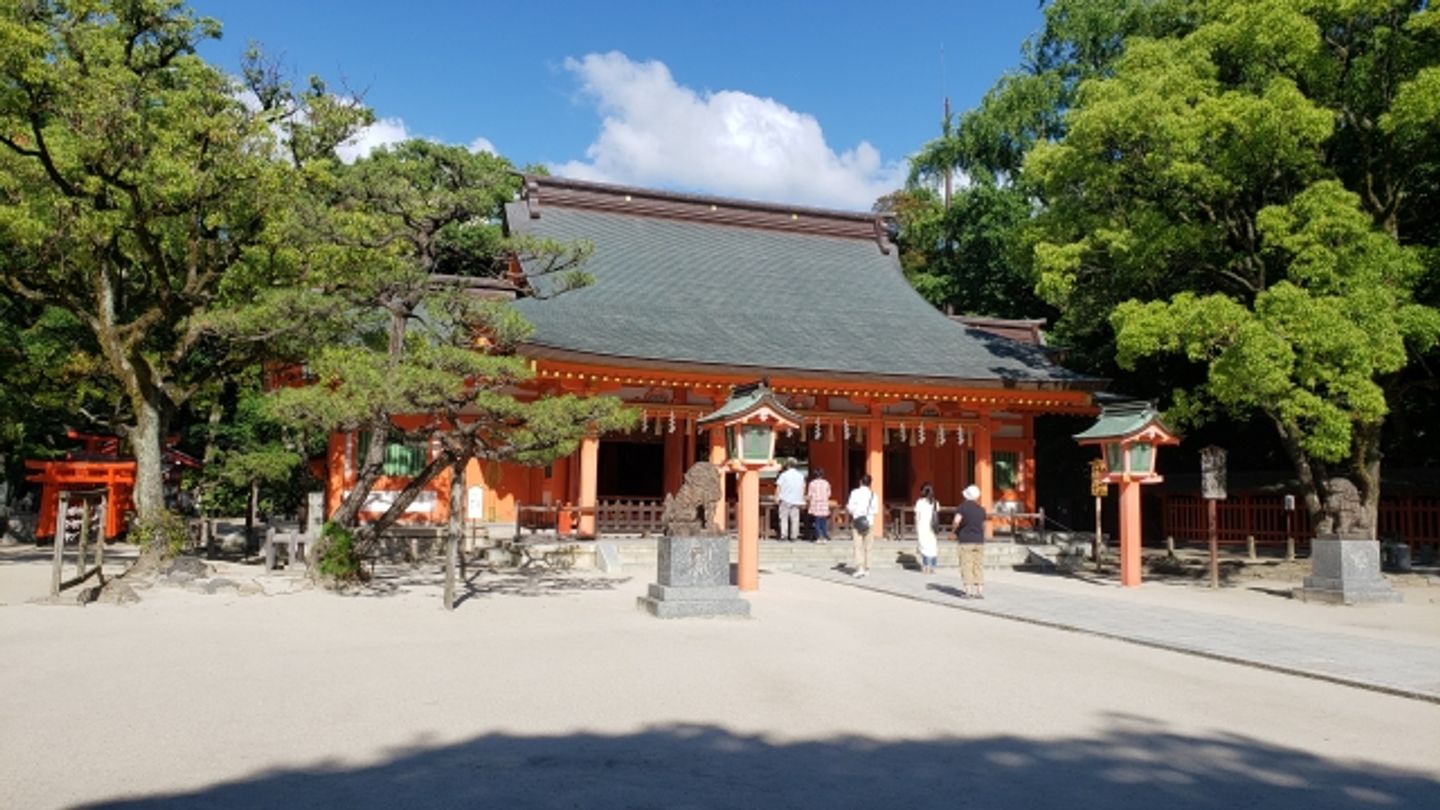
(505, 194, 1102, 388)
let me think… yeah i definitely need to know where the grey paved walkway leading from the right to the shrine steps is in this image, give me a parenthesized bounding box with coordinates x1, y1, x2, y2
(792, 568, 1440, 703)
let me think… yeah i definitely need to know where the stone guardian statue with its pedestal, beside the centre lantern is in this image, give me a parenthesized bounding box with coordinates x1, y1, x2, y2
(636, 461, 750, 618)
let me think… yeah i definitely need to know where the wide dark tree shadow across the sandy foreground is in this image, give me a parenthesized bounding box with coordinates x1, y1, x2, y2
(85, 716, 1440, 810)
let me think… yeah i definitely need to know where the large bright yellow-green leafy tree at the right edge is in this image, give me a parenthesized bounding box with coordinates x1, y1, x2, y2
(1022, 0, 1440, 527)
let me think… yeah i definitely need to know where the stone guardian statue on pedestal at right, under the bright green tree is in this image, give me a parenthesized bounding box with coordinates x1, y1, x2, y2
(1295, 479, 1403, 605)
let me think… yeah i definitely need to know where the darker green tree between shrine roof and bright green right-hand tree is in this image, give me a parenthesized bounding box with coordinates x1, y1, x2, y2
(893, 0, 1185, 321)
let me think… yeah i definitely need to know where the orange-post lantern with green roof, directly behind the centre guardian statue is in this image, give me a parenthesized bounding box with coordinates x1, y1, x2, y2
(696, 379, 801, 591)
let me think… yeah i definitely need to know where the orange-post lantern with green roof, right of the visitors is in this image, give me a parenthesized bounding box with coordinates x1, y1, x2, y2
(1074, 401, 1179, 588)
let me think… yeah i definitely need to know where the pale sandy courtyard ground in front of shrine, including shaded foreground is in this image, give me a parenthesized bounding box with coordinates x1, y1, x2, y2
(0, 541, 1440, 809)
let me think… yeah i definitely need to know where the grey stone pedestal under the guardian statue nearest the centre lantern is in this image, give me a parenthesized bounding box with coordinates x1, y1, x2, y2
(635, 535, 750, 618)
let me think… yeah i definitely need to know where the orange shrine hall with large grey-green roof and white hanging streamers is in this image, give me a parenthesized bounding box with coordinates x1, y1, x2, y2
(327, 176, 1104, 536)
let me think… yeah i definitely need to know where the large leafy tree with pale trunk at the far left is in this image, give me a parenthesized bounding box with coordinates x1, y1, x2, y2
(0, 0, 364, 553)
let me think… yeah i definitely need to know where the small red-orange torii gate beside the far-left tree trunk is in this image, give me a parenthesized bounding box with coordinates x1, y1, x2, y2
(24, 431, 200, 540)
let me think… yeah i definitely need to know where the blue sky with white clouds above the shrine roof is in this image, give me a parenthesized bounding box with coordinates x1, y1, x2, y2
(192, 0, 1041, 209)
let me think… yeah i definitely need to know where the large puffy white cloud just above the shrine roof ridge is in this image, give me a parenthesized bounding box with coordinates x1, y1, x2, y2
(550, 50, 906, 209)
